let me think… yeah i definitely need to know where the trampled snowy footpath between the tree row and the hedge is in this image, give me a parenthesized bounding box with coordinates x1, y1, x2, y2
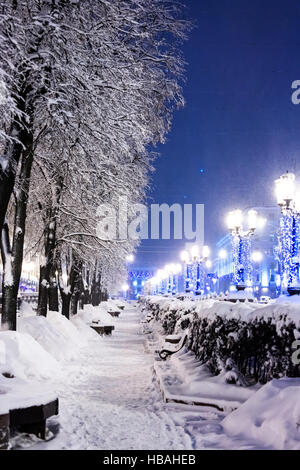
(13, 306, 260, 450)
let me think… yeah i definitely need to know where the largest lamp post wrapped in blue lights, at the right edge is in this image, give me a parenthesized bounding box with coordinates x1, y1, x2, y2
(275, 172, 300, 295)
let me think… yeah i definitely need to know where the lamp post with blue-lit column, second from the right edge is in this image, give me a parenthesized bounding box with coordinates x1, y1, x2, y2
(227, 209, 257, 290)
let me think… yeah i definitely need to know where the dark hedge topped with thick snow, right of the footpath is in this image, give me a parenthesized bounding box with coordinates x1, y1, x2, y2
(143, 297, 300, 383)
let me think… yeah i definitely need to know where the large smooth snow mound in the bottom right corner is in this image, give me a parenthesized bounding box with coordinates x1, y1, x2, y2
(222, 378, 300, 450)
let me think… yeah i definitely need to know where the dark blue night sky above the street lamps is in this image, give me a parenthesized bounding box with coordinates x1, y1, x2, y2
(135, 0, 300, 267)
